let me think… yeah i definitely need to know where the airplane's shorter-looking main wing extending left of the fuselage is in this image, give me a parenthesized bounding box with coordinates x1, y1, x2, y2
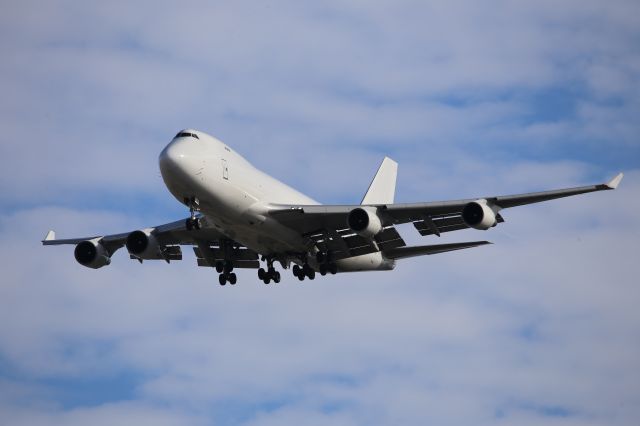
(42, 216, 259, 268)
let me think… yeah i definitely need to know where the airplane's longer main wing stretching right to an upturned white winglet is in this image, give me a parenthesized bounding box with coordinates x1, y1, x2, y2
(269, 173, 623, 257)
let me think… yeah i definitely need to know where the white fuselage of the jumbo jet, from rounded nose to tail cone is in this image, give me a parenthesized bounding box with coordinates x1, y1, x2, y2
(159, 130, 395, 272)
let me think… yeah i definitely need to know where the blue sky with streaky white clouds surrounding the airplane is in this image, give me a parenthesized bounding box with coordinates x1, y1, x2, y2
(0, 0, 640, 426)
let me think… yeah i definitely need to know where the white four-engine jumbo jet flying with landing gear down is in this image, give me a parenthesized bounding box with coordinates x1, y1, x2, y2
(42, 129, 623, 285)
